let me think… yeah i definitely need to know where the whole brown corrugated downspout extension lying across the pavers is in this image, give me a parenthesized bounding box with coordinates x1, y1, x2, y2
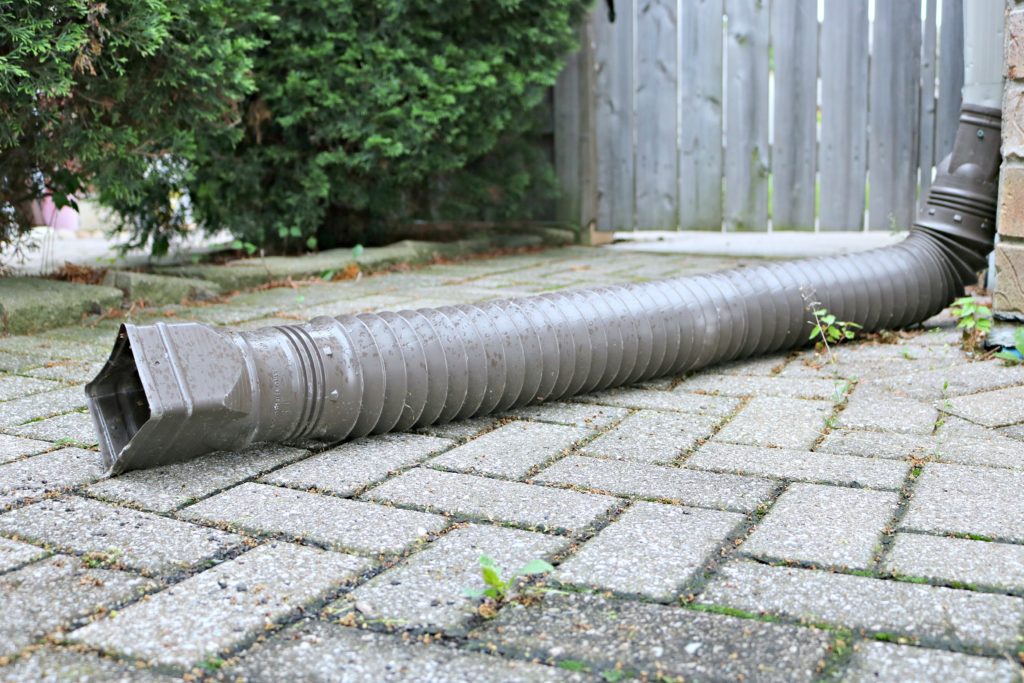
(86, 105, 999, 473)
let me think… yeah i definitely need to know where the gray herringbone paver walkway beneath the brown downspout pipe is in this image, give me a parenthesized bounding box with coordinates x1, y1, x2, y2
(0, 249, 1024, 682)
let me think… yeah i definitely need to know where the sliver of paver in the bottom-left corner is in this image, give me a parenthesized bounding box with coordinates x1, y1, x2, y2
(0, 647, 174, 683)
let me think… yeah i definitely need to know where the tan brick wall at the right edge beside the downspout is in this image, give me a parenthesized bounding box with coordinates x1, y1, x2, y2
(994, 1, 1024, 312)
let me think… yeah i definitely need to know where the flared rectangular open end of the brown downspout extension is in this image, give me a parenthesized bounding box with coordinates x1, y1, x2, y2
(85, 323, 252, 475)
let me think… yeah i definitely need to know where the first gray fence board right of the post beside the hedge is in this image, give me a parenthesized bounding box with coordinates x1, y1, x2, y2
(594, 0, 635, 230)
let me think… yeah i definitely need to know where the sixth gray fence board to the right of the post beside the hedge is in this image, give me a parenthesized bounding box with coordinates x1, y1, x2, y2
(818, 0, 868, 230)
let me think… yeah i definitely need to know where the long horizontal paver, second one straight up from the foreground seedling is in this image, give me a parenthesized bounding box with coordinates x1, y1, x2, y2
(364, 468, 618, 531)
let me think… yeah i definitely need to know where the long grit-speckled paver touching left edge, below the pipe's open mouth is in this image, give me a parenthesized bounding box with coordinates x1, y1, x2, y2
(0, 496, 242, 574)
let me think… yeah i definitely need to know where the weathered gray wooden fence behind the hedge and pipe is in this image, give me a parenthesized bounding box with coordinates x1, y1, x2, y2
(554, 0, 964, 230)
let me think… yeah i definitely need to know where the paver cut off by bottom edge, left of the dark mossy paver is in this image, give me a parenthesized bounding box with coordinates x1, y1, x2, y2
(234, 622, 591, 683)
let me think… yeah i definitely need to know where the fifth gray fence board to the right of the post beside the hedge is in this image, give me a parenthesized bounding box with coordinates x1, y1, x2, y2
(771, 0, 819, 230)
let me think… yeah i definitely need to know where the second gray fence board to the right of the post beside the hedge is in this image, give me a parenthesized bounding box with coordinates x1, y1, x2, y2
(636, 0, 679, 230)
